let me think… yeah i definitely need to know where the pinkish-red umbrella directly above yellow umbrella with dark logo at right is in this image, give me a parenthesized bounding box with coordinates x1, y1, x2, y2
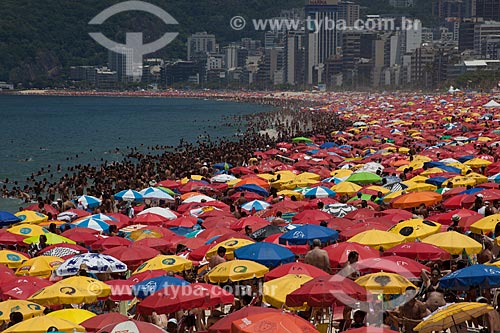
(353, 256, 429, 279)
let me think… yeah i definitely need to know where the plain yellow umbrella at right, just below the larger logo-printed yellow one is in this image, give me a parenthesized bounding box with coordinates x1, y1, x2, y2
(422, 231, 483, 255)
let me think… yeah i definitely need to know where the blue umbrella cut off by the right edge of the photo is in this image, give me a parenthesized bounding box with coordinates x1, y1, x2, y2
(439, 265, 500, 290)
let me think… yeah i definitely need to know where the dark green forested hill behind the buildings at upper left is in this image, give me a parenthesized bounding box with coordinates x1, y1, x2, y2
(0, 0, 427, 86)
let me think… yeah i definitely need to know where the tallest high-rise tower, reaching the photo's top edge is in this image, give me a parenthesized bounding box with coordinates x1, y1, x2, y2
(305, 0, 338, 84)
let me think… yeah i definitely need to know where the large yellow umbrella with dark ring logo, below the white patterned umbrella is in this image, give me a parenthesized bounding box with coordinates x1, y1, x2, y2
(28, 276, 111, 305)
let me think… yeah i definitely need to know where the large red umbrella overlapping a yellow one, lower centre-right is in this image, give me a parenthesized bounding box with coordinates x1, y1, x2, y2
(286, 275, 369, 307)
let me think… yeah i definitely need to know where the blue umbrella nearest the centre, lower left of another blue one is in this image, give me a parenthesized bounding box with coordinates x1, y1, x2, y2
(234, 243, 295, 267)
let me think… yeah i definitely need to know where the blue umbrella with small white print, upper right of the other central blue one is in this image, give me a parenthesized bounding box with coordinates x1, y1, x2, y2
(279, 224, 339, 245)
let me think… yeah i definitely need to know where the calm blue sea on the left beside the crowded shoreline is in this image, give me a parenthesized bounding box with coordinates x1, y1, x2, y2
(0, 95, 272, 212)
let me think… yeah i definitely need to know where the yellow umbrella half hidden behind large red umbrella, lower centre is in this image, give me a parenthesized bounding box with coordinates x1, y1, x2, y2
(262, 274, 313, 310)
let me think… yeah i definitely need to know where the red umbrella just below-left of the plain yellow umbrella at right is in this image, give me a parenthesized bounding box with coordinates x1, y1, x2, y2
(383, 242, 451, 260)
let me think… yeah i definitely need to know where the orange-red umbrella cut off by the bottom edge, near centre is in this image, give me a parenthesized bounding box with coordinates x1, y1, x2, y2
(231, 312, 318, 333)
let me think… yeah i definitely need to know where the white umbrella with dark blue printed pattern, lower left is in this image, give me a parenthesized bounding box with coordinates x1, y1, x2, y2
(56, 253, 127, 276)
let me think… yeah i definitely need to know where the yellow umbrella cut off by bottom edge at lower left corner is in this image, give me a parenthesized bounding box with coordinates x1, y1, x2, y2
(3, 316, 85, 333)
